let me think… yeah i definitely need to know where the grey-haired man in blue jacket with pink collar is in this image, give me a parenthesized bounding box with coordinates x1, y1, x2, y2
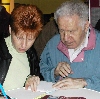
(39, 0, 100, 91)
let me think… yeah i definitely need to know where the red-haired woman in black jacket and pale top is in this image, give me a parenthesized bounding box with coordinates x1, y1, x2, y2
(0, 4, 43, 98)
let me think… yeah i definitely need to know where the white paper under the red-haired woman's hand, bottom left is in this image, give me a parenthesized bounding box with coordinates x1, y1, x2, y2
(6, 81, 56, 99)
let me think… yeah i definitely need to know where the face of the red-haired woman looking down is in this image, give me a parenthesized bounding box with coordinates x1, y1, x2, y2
(11, 33, 35, 53)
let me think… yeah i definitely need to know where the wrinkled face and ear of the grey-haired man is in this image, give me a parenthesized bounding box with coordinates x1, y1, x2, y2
(57, 15, 89, 49)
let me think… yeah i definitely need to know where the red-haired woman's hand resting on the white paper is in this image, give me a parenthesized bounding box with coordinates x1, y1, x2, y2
(25, 76, 40, 91)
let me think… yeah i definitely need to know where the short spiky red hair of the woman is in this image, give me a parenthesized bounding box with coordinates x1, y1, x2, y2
(10, 4, 43, 37)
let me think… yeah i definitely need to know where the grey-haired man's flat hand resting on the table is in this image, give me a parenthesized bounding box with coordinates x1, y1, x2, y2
(53, 78, 87, 89)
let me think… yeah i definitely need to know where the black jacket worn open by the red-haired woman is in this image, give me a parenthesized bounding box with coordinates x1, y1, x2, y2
(0, 38, 41, 85)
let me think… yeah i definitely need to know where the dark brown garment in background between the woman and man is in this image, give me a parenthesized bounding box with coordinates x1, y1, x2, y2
(34, 20, 58, 58)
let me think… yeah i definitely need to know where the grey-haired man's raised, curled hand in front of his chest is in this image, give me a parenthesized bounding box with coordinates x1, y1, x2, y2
(54, 62, 73, 77)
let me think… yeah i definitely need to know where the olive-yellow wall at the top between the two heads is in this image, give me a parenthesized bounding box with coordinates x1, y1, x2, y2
(15, 0, 66, 14)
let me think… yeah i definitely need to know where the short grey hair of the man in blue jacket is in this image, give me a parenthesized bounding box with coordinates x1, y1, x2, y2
(54, 0, 89, 29)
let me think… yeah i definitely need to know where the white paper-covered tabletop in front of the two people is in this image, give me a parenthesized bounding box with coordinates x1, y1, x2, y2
(6, 81, 100, 99)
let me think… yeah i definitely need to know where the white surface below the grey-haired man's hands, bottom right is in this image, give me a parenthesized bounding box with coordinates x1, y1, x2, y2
(52, 88, 100, 99)
